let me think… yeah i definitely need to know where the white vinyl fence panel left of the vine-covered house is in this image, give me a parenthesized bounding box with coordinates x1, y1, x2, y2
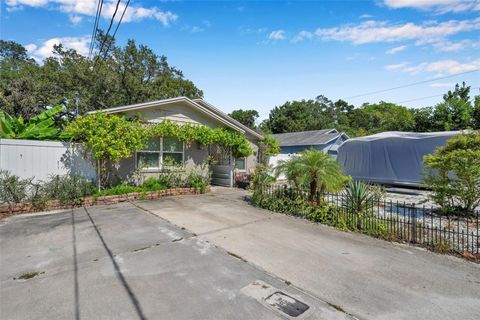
(0, 139, 96, 181)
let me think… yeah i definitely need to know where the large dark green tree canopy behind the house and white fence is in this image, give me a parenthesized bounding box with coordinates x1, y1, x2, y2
(0, 32, 203, 120)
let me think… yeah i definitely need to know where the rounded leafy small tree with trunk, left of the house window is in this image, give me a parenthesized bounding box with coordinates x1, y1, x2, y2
(66, 112, 148, 190)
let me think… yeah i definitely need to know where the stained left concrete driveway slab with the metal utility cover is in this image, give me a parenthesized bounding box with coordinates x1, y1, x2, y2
(0, 196, 351, 320)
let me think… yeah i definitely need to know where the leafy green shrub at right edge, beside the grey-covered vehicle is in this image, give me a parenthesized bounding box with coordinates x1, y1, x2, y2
(424, 132, 480, 215)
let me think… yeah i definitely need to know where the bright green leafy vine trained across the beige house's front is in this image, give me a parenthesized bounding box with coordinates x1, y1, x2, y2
(66, 112, 252, 170)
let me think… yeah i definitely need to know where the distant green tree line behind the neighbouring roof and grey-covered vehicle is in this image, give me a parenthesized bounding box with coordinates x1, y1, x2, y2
(260, 83, 480, 136)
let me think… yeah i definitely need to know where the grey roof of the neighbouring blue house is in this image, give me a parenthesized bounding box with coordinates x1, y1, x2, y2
(271, 129, 348, 147)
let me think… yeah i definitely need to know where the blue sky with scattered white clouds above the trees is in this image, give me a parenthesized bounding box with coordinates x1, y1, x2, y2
(0, 0, 480, 119)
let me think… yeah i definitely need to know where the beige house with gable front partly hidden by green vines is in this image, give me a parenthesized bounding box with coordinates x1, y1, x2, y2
(91, 97, 263, 186)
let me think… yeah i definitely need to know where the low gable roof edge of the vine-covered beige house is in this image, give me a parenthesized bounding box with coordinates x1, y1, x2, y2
(87, 97, 263, 139)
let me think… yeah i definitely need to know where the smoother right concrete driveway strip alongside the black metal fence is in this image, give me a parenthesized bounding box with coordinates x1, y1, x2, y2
(134, 188, 480, 320)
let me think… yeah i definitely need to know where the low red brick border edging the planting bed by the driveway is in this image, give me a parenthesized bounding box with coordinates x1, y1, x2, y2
(0, 186, 211, 220)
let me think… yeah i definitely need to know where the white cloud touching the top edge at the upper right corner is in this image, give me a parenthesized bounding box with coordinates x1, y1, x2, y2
(384, 0, 480, 14)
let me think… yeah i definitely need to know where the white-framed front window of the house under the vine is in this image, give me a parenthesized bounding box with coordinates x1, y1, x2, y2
(137, 137, 184, 170)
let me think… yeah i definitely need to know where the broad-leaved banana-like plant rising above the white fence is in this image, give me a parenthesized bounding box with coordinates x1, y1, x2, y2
(0, 106, 68, 140)
